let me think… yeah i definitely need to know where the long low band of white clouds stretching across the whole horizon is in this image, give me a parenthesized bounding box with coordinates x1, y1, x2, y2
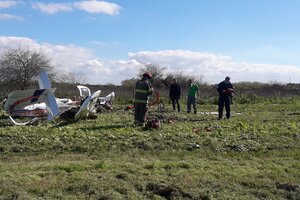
(0, 36, 300, 84)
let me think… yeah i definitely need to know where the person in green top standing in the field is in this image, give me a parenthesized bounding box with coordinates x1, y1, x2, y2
(187, 79, 200, 114)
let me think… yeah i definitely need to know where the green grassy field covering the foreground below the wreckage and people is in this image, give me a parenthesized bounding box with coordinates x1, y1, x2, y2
(0, 101, 300, 200)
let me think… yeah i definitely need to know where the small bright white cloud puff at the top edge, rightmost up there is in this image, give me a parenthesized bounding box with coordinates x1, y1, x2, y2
(74, 0, 121, 15)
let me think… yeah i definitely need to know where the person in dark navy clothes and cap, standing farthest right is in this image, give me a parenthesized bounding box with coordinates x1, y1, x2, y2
(217, 76, 234, 119)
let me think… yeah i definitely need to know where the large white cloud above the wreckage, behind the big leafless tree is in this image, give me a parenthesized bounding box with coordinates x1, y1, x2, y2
(0, 36, 115, 84)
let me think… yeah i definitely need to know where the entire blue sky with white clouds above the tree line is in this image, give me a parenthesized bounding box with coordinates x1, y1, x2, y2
(0, 0, 300, 85)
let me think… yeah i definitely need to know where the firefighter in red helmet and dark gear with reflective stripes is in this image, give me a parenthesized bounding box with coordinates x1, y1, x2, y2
(134, 72, 153, 126)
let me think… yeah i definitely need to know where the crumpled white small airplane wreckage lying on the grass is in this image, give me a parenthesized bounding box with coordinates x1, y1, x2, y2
(2, 71, 115, 125)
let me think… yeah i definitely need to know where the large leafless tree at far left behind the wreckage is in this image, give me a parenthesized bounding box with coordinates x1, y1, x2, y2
(0, 47, 53, 90)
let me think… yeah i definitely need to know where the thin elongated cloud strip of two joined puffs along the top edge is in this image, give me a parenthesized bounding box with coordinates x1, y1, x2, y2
(32, 0, 121, 15)
